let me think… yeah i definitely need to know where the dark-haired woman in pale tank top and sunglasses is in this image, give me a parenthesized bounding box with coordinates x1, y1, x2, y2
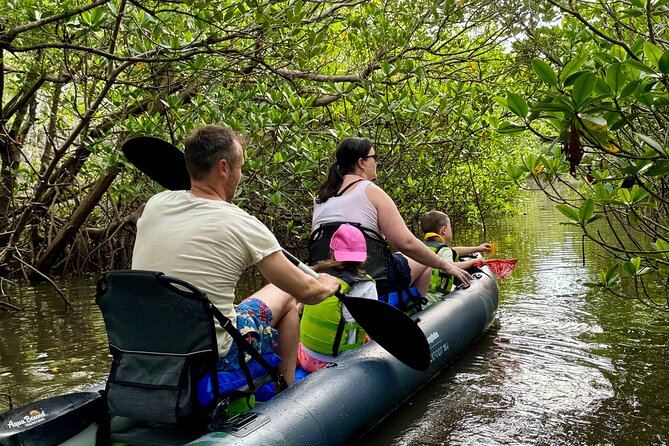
(312, 137, 471, 295)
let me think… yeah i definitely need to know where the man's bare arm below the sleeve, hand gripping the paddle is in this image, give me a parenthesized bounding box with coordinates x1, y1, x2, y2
(256, 251, 340, 305)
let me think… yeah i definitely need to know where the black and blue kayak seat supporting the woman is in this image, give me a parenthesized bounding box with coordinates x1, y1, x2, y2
(308, 221, 427, 315)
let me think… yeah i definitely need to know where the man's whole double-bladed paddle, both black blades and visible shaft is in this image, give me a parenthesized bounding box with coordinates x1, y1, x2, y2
(121, 136, 430, 371)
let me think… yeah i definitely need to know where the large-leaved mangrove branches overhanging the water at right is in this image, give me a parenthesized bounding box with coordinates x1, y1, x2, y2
(498, 0, 669, 310)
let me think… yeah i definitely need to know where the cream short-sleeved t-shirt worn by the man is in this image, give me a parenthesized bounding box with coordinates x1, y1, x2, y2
(132, 191, 281, 356)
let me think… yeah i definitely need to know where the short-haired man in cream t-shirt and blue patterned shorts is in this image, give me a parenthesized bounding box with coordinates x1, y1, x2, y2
(132, 125, 339, 385)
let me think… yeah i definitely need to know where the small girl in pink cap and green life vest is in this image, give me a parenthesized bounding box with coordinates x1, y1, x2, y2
(297, 224, 378, 372)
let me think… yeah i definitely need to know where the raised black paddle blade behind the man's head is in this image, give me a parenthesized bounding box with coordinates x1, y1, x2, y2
(121, 136, 190, 190)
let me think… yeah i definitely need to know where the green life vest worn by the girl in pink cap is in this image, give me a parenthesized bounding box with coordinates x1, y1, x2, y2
(300, 272, 372, 356)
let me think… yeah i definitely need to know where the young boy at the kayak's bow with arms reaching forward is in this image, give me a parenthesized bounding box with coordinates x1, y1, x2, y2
(420, 210, 492, 305)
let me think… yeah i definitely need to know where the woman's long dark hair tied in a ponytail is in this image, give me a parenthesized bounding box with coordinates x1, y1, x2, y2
(316, 137, 372, 203)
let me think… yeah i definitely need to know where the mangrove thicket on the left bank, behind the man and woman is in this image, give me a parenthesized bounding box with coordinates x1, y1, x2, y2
(0, 0, 516, 277)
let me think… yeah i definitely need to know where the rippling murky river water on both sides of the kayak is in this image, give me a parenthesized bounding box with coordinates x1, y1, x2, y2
(0, 193, 669, 446)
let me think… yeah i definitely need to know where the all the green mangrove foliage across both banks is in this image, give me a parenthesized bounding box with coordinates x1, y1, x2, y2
(0, 0, 669, 308)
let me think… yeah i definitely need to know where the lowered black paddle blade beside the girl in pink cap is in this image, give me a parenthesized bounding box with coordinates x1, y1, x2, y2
(337, 293, 430, 372)
